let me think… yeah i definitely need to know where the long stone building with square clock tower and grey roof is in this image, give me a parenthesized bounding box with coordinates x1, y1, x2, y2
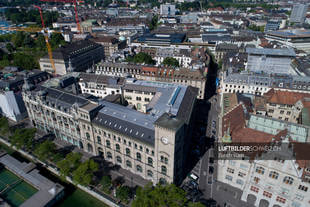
(23, 77, 197, 183)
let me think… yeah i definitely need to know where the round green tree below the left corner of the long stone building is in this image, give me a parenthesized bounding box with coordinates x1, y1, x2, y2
(10, 128, 36, 150)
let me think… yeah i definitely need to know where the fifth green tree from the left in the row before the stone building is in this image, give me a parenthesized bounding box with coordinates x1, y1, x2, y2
(72, 160, 99, 186)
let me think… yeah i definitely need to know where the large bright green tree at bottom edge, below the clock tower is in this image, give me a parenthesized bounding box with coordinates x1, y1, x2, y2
(131, 183, 188, 207)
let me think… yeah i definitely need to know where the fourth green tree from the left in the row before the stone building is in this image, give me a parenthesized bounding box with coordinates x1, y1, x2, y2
(57, 152, 82, 177)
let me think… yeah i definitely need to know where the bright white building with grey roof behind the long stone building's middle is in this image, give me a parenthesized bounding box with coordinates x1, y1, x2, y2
(79, 73, 125, 98)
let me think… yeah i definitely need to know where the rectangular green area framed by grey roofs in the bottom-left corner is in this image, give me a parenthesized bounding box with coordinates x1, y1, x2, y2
(0, 169, 38, 207)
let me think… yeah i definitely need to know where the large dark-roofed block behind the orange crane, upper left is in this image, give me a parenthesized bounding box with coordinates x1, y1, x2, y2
(40, 40, 104, 75)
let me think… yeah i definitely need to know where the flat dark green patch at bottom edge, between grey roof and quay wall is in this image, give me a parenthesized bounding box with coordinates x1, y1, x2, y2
(57, 189, 108, 207)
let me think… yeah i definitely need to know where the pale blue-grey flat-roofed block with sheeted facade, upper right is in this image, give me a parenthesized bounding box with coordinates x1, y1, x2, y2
(246, 48, 296, 74)
